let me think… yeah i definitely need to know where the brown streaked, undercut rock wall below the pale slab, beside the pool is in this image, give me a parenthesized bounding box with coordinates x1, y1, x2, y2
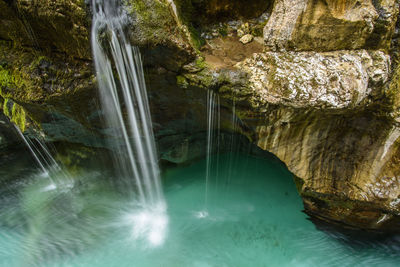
(252, 108, 400, 231)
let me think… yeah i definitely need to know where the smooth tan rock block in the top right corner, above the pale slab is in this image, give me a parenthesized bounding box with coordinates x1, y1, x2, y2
(264, 0, 398, 51)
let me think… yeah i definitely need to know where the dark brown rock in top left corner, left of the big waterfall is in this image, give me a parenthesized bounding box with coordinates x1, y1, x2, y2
(0, 0, 91, 59)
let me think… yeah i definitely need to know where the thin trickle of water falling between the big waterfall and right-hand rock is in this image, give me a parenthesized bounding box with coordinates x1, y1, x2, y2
(205, 90, 221, 205)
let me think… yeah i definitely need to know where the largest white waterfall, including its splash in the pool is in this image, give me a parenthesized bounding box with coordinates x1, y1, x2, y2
(92, 0, 168, 245)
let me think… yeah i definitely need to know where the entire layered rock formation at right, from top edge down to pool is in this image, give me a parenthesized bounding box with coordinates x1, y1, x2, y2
(183, 0, 400, 231)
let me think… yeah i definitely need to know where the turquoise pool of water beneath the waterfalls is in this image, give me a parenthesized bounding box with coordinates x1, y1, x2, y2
(0, 154, 400, 267)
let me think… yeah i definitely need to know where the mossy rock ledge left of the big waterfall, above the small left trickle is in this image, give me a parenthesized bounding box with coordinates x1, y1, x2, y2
(0, 44, 97, 137)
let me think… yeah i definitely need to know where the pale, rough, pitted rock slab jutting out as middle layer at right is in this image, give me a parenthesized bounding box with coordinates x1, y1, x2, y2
(237, 50, 390, 109)
